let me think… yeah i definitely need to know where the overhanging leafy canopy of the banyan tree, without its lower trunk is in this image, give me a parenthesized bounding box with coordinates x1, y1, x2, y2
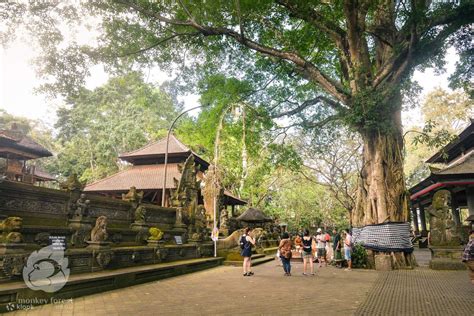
(0, 0, 474, 138)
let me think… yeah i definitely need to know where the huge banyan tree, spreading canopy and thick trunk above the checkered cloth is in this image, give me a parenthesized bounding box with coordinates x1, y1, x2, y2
(4, 0, 474, 265)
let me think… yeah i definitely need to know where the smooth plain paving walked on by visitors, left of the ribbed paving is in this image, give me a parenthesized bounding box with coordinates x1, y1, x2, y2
(8, 262, 378, 316)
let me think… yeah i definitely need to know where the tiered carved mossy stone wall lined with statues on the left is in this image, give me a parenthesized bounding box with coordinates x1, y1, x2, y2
(0, 181, 218, 282)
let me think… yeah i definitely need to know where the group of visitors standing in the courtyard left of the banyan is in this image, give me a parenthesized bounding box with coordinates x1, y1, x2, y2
(240, 228, 353, 276)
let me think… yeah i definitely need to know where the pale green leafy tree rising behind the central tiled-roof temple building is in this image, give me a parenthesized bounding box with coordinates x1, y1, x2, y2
(51, 73, 180, 182)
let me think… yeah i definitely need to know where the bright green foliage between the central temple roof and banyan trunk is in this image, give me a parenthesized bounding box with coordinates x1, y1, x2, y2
(176, 74, 301, 205)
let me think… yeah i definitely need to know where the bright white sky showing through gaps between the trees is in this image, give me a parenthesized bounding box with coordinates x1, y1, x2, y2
(0, 37, 458, 126)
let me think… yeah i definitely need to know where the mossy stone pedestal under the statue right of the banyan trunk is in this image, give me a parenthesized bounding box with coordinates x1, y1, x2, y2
(430, 246, 466, 270)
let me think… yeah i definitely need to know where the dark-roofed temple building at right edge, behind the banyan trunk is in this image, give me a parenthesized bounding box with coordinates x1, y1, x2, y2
(409, 119, 474, 237)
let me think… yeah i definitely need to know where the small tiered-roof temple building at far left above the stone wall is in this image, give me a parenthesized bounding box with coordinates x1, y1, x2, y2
(0, 124, 56, 185)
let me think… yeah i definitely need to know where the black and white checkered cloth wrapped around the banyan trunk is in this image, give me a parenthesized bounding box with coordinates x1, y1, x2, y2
(352, 223, 413, 252)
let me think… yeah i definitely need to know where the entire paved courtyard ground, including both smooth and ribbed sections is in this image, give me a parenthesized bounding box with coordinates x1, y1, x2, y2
(7, 254, 474, 316)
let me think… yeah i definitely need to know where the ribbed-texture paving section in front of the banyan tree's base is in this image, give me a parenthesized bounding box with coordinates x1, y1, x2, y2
(355, 268, 474, 316)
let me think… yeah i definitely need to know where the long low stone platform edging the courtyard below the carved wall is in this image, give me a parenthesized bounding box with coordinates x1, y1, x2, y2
(0, 257, 223, 312)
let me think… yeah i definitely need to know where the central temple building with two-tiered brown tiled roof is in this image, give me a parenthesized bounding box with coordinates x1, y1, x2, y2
(84, 135, 246, 214)
